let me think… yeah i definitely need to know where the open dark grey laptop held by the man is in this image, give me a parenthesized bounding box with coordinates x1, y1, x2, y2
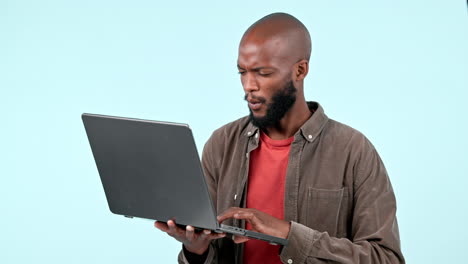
(82, 113, 288, 246)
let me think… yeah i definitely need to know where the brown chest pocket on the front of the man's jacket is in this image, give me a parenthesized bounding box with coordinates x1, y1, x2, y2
(306, 187, 347, 236)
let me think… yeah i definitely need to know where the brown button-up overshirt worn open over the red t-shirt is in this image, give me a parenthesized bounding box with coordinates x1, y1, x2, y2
(179, 102, 405, 263)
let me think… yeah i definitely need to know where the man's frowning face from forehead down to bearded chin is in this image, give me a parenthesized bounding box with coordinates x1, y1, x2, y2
(237, 38, 296, 128)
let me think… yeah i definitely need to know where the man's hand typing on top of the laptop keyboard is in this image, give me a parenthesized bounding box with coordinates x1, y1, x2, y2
(218, 207, 291, 243)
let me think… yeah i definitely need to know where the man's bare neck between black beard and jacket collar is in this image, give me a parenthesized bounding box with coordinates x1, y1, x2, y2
(264, 99, 312, 140)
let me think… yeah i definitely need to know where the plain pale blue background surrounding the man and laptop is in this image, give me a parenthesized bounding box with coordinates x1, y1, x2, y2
(0, 0, 468, 264)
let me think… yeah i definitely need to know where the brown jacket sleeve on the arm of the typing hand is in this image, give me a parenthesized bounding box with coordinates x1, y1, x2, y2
(280, 138, 405, 264)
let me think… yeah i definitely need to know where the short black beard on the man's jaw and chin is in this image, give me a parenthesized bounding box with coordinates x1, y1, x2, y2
(245, 81, 297, 130)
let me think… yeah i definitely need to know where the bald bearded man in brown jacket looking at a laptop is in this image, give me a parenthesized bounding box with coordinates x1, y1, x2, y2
(155, 13, 404, 263)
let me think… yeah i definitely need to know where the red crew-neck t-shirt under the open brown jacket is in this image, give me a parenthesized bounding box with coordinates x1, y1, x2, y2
(244, 133, 294, 264)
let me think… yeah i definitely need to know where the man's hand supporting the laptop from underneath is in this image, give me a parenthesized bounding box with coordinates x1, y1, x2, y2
(154, 220, 226, 255)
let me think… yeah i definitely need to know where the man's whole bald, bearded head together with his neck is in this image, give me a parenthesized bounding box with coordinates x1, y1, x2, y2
(237, 13, 311, 133)
